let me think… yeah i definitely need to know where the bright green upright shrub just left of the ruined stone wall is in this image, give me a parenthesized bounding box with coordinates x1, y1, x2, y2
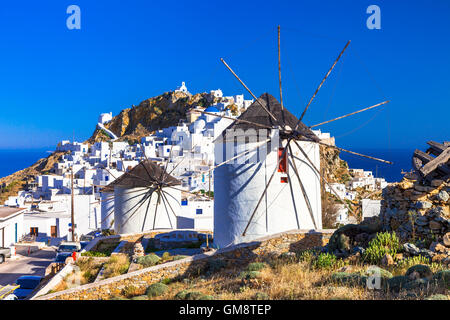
(363, 232, 401, 264)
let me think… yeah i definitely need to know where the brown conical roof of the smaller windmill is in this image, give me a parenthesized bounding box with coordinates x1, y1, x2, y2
(102, 160, 181, 192)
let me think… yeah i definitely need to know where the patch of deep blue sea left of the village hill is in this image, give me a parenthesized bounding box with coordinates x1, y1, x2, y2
(0, 148, 50, 178)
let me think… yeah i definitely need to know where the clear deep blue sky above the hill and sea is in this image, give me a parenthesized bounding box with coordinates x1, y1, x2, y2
(0, 0, 450, 149)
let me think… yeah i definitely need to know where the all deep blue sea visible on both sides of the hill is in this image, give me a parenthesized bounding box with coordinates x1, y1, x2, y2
(0, 148, 414, 182)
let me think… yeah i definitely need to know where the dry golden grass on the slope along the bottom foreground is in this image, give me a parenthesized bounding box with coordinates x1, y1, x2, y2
(128, 256, 448, 300)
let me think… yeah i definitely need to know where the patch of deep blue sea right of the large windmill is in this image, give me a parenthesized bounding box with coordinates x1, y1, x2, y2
(340, 149, 414, 182)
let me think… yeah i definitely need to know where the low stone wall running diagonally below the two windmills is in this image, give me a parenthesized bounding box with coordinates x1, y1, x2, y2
(36, 230, 334, 300)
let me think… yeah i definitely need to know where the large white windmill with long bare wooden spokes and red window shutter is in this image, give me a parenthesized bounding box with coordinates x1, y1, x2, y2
(199, 27, 392, 247)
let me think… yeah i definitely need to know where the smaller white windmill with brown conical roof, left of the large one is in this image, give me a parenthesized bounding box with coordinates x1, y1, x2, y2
(94, 141, 213, 234)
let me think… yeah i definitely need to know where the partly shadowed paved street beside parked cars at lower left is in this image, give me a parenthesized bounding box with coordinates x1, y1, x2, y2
(0, 248, 56, 286)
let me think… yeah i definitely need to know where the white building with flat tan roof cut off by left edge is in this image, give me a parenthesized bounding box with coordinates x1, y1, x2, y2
(0, 207, 26, 247)
